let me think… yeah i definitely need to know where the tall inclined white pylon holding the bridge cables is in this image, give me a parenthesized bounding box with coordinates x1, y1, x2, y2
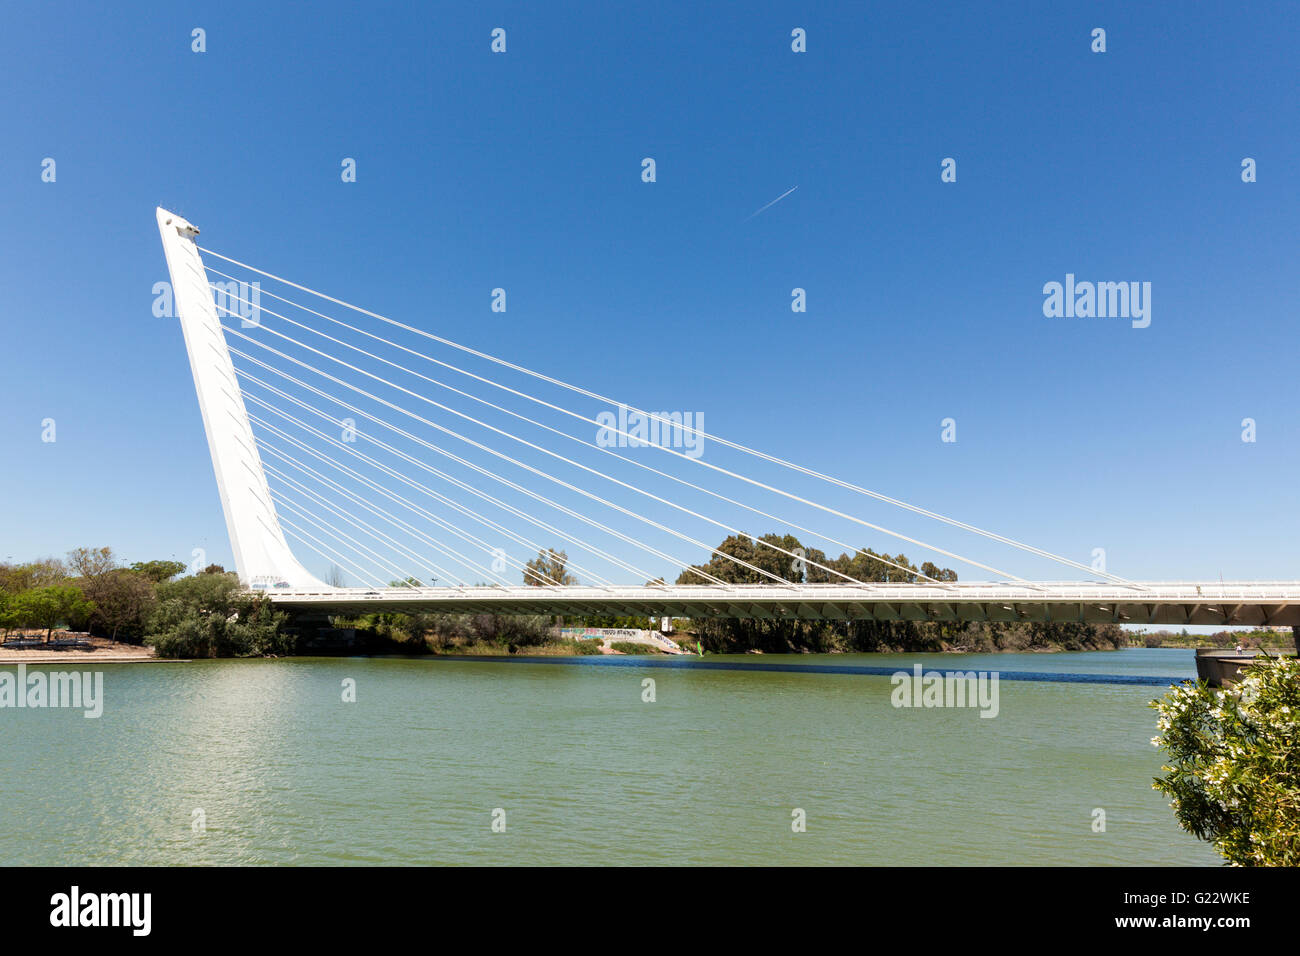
(157, 207, 330, 591)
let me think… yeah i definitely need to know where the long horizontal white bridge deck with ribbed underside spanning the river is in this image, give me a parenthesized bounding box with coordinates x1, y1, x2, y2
(267, 583, 1300, 627)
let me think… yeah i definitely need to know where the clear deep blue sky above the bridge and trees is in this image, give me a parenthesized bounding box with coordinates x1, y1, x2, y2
(0, 0, 1300, 583)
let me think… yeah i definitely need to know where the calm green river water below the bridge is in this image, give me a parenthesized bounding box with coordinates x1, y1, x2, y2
(0, 650, 1218, 865)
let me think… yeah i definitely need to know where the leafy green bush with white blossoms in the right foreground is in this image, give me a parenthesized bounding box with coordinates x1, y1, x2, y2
(1152, 657, 1300, 866)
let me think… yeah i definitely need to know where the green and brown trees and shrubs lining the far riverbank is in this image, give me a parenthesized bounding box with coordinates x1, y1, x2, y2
(0, 535, 1292, 658)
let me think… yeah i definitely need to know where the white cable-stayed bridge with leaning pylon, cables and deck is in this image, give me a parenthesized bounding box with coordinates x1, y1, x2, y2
(157, 208, 1300, 626)
